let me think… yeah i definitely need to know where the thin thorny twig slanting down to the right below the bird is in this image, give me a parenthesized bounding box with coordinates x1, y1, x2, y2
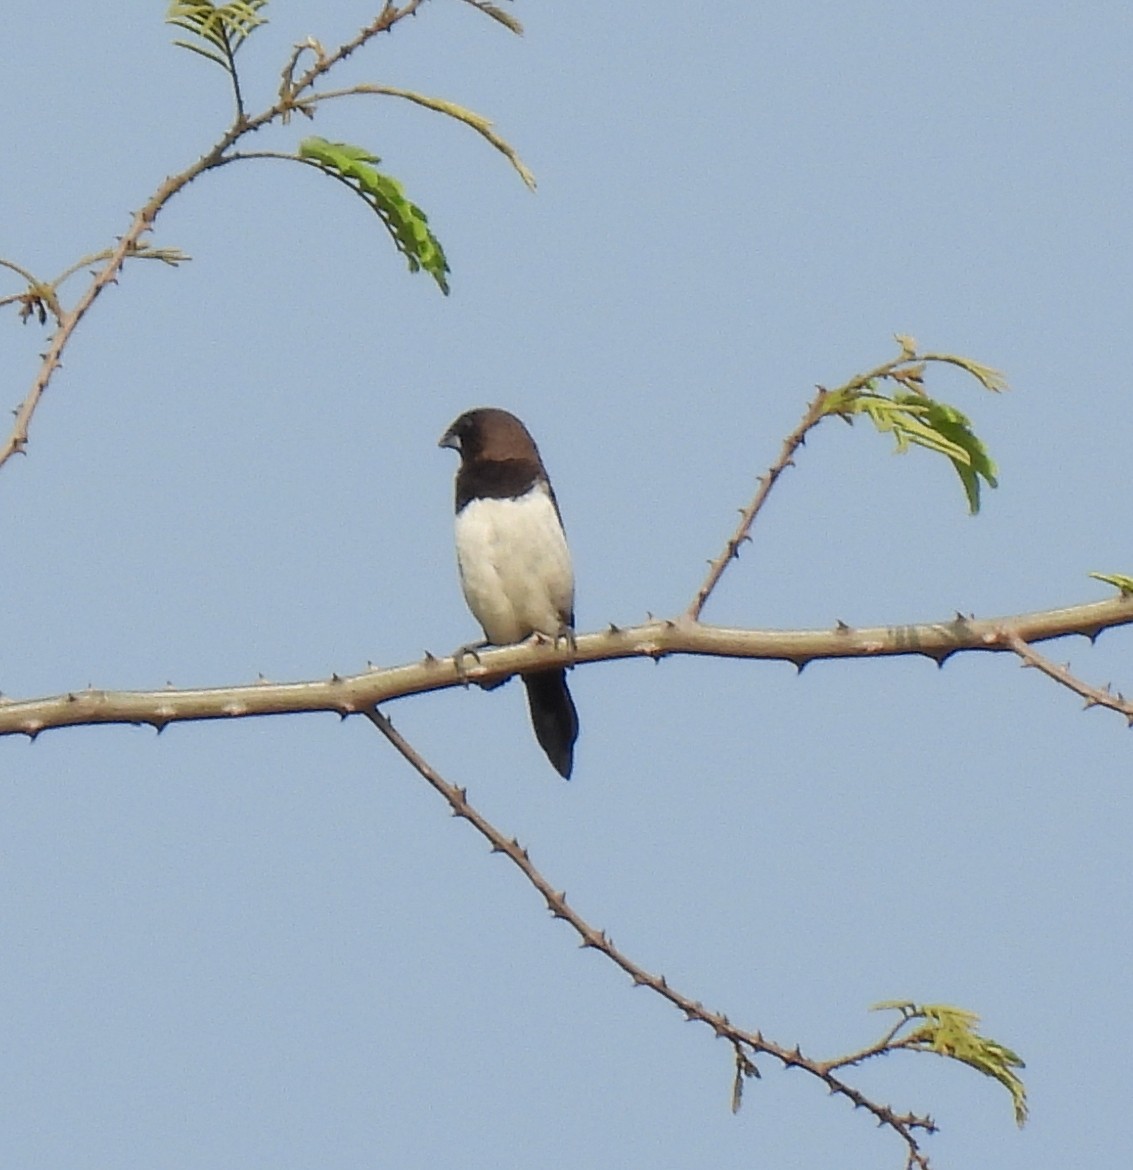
(362, 707, 936, 1170)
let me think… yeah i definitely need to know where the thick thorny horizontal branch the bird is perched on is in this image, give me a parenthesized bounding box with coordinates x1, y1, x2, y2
(0, 594, 1133, 738)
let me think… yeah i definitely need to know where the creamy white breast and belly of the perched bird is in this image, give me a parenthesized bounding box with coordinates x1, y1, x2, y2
(456, 483, 575, 645)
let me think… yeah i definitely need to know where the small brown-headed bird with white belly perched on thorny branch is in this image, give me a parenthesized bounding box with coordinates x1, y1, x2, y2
(438, 406, 578, 780)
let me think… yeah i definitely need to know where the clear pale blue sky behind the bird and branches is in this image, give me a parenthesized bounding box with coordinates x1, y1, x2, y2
(0, 0, 1133, 1170)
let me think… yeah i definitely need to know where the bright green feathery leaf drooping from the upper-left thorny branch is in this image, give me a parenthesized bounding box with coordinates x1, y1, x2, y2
(298, 138, 449, 296)
